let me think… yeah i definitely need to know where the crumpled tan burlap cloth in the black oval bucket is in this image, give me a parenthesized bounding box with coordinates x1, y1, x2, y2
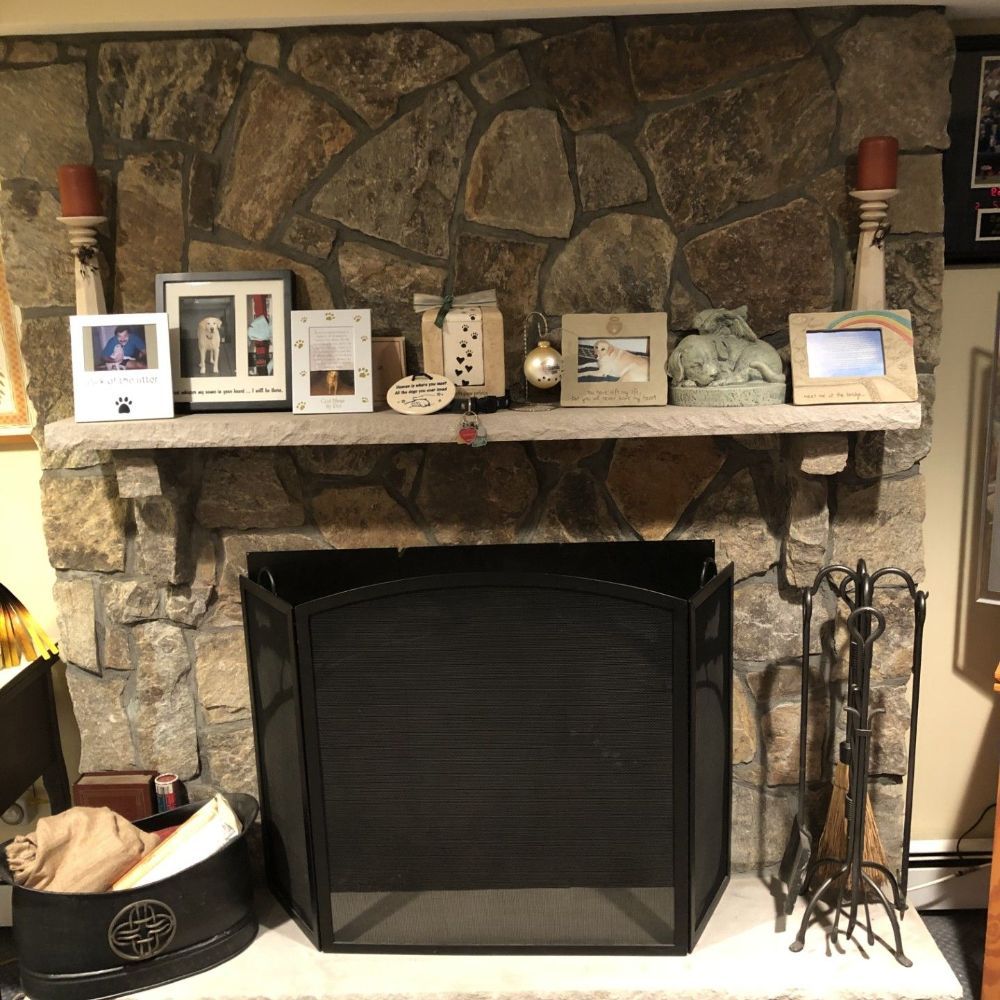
(7, 806, 160, 892)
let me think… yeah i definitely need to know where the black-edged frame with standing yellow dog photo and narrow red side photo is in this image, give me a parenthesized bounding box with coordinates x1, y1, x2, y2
(156, 270, 292, 413)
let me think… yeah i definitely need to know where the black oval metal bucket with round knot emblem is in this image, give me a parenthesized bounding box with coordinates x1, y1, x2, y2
(0, 794, 257, 1000)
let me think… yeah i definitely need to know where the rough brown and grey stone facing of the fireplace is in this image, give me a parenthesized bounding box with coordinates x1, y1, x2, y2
(0, 7, 953, 868)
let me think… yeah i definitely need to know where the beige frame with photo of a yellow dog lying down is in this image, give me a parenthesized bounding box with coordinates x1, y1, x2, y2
(560, 312, 667, 406)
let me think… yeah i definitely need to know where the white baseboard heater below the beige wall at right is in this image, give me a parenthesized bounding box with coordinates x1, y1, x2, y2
(907, 838, 993, 910)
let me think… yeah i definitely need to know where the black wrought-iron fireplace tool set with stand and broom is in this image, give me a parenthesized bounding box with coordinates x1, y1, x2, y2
(785, 560, 927, 967)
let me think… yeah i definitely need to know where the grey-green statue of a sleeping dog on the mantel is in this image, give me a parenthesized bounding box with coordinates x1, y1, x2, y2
(667, 306, 785, 387)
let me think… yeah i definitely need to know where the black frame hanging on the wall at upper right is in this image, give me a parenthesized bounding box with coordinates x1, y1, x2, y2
(944, 35, 1000, 265)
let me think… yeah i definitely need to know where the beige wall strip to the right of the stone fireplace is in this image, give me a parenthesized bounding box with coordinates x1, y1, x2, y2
(913, 267, 1000, 840)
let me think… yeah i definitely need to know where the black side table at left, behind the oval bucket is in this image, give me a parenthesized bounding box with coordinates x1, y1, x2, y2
(0, 659, 72, 813)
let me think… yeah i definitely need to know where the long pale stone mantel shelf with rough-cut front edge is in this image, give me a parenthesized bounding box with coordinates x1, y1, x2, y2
(45, 403, 920, 451)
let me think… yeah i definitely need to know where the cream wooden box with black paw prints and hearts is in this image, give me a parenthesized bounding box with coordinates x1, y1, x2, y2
(420, 306, 507, 399)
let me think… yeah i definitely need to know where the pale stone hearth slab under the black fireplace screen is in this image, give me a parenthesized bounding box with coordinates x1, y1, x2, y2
(137, 876, 962, 1000)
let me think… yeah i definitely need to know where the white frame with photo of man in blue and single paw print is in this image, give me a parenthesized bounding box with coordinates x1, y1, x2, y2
(69, 313, 174, 423)
